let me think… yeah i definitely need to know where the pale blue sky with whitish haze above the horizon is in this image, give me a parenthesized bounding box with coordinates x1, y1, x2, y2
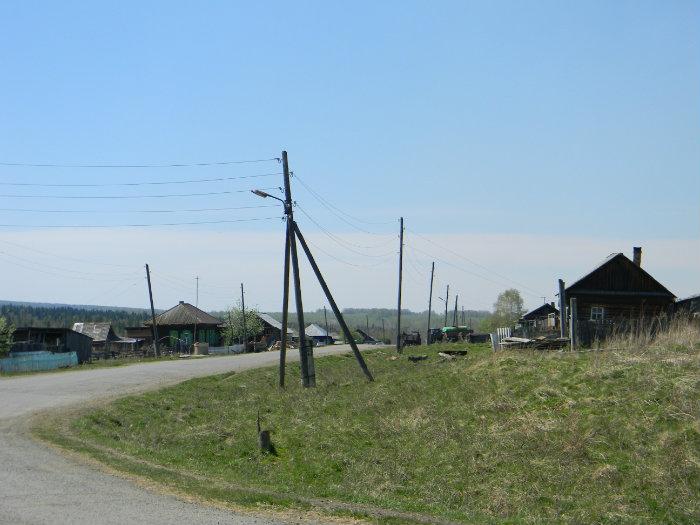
(0, 1, 700, 310)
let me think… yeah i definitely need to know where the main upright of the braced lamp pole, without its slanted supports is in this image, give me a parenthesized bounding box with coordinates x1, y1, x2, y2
(282, 151, 316, 387)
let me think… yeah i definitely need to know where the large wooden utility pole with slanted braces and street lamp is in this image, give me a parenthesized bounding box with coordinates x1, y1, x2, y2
(252, 151, 373, 387)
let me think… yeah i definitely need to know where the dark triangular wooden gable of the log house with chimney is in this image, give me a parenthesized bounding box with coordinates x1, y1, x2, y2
(566, 253, 676, 299)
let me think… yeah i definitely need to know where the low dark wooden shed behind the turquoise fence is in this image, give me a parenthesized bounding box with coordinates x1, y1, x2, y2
(11, 326, 92, 363)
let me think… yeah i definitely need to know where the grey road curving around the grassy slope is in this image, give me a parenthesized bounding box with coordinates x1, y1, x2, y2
(0, 345, 372, 525)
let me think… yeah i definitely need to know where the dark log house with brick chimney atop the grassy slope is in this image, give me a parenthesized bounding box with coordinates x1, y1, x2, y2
(565, 248, 676, 322)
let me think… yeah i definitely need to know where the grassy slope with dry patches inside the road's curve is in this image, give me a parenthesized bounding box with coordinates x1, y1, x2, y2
(39, 342, 700, 523)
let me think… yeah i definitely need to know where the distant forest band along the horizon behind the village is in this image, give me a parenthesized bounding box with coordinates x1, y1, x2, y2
(0, 303, 491, 341)
